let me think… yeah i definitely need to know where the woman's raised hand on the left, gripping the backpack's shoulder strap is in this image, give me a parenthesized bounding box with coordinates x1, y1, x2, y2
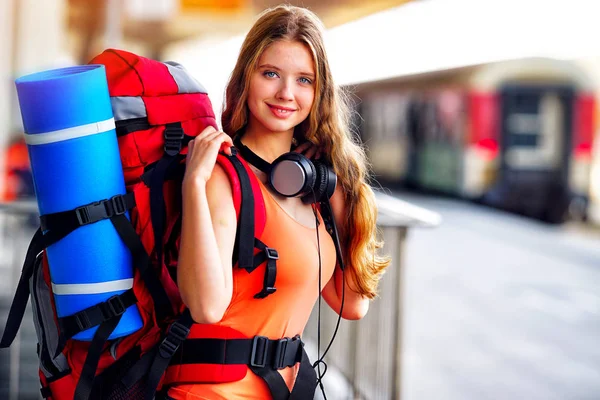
(183, 126, 233, 186)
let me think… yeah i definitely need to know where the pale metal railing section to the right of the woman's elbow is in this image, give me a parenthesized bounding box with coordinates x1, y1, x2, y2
(304, 192, 441, 400)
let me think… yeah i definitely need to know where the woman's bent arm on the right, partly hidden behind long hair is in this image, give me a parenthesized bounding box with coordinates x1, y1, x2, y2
(321, 185, 369, 320)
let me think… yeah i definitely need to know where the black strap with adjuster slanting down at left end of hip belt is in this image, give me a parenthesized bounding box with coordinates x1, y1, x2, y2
(145, 308, 194, 399)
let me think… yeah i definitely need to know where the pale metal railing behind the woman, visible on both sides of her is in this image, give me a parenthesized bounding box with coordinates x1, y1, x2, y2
(0, 192, 441, 400)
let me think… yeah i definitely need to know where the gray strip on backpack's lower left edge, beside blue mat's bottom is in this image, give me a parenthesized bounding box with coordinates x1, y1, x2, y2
(29, 261, 69, 378)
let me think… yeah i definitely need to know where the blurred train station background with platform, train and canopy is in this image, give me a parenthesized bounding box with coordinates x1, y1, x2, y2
(0, 0, 600, 400)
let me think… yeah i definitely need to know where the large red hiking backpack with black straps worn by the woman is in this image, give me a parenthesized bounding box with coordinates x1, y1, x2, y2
(0, 49, 332, 400)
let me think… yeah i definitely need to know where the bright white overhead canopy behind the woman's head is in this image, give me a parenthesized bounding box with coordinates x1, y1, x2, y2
(168, 0, 600, 117)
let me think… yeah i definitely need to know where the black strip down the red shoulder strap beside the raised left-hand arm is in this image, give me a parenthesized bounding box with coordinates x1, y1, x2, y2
(226, 156, 254, 270)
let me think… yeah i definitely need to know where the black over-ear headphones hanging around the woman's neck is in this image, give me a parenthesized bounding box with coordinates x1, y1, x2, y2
(233, 135, 337, 204)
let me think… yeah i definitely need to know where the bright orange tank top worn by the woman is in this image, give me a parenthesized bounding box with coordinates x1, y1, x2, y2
(168, 179, 336, 400)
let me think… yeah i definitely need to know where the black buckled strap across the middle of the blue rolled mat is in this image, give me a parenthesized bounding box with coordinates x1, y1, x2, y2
(40, 193, 135, 233)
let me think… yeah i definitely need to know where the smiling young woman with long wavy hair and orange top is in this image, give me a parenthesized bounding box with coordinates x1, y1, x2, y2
(169, 6, 389, 399)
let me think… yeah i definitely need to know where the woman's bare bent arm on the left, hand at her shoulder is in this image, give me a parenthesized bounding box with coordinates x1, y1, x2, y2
(177, 129, 237, 324)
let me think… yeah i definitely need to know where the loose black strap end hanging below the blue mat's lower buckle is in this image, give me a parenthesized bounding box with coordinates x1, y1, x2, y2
(73, 314, 123, 400)
